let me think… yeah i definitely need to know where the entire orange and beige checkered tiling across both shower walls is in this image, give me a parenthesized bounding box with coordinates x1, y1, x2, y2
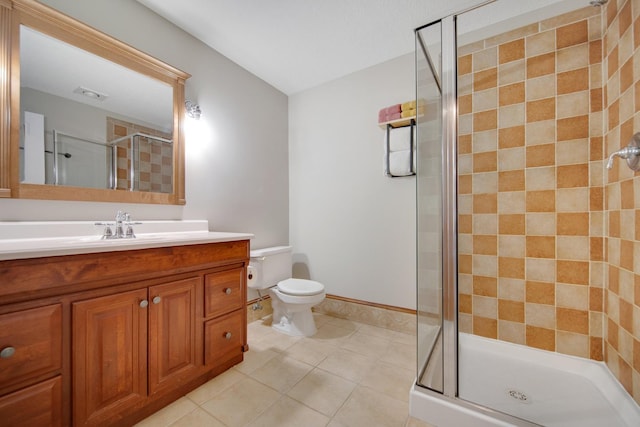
(458, 0, 640, 401)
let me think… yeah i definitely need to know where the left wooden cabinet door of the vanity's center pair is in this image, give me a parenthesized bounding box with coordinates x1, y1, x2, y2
(72, 289, 148, 425)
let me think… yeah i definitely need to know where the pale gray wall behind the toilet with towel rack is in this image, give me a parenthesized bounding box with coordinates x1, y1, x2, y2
(289, 54, 416, 309)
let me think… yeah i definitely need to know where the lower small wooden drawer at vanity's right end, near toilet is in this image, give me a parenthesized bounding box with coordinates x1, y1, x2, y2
(204, 310, 244, 366)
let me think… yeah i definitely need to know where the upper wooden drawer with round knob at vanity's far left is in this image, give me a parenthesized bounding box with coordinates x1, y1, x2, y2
(0, 304, 62, 385)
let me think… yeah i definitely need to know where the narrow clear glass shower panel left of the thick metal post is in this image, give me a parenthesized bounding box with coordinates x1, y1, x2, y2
(416, 21, 444, 393)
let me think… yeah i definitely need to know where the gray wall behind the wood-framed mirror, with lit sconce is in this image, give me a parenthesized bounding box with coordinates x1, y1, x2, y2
(0, 0, 289, 251)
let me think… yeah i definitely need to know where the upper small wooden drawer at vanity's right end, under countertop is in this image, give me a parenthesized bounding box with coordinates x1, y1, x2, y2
(204, 267, 245, 317)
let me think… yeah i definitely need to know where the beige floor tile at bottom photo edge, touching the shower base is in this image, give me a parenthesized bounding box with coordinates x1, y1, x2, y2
(330, 386, 409, 427)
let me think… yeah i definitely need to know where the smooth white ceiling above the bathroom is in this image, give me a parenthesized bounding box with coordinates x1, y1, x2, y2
(138, 0, 432, 95)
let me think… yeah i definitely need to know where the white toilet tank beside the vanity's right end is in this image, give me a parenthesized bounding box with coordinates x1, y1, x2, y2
(247, 246, 292, 289)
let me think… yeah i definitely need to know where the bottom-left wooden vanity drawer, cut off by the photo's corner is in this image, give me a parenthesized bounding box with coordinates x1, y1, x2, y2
(0, 377, 62, 427)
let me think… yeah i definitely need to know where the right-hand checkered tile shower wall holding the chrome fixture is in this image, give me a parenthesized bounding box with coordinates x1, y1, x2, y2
(603, 0, 640, 402)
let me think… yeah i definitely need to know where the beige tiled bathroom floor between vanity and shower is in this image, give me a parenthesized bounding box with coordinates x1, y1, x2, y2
(137, 314, 436, 427)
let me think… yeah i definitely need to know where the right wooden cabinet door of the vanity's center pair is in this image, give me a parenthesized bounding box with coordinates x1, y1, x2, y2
(149, 277, 202, 394)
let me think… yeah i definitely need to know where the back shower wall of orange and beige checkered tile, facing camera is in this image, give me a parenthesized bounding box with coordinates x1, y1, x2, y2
(458, 7, 604, 360)
